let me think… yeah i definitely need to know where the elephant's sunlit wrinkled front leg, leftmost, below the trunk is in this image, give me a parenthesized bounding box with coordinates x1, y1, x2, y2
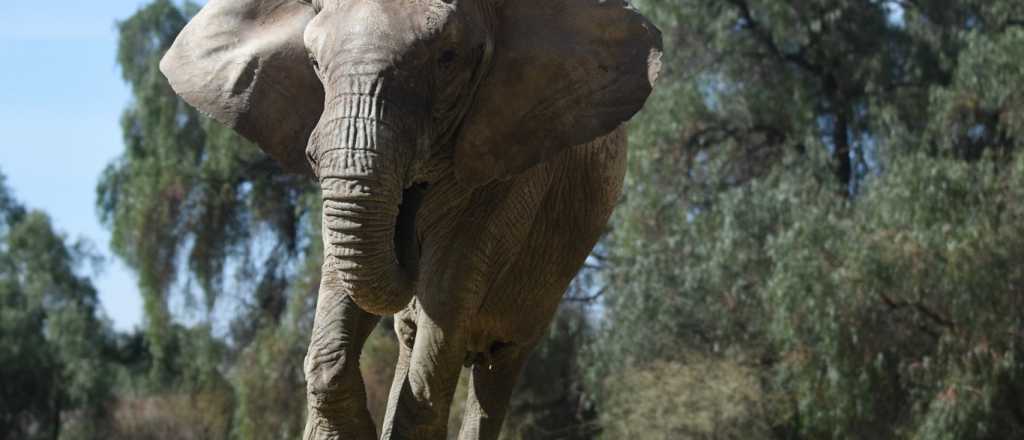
(302, 271, 380, 440)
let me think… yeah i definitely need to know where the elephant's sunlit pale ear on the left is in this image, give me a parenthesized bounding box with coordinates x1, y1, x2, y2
(160, 0, 324, 175)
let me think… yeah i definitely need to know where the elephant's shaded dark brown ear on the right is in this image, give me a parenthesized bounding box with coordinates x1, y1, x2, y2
(455, 0, 662, 186)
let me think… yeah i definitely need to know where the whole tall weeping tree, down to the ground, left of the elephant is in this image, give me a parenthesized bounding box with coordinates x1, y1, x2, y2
(96, 0, 321, 438)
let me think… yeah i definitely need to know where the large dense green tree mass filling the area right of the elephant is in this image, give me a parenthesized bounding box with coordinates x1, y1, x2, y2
(588, 0, 1024, 438)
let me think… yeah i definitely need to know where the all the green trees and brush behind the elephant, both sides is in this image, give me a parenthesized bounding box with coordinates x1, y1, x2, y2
(0, 0, 1024, 439)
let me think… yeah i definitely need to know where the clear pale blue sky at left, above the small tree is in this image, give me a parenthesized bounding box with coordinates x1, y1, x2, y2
(0, 0, 167, 329)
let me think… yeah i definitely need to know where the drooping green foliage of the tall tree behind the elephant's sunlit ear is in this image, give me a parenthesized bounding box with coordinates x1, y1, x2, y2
(97, 0, 318, 385)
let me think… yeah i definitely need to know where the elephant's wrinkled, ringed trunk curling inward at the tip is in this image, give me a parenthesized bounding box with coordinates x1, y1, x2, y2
(310, 76, 418, 315)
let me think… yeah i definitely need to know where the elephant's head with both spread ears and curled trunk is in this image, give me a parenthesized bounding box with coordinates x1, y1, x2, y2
(161, 0, 660, 314)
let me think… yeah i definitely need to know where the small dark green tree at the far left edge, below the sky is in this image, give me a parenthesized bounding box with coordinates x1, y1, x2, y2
(0, 169, 113, 439)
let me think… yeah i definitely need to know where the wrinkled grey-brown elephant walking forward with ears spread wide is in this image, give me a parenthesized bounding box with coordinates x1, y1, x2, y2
(160, 0, 662, 439)
